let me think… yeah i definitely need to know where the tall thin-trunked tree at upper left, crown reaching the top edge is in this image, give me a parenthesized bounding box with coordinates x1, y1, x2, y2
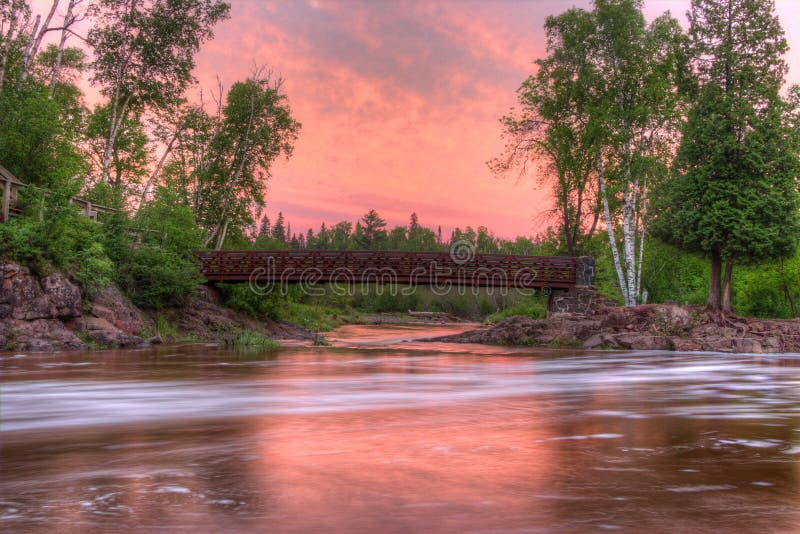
(87, 0, 230, 186)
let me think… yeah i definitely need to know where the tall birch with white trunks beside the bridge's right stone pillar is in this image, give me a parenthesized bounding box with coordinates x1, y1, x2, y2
(589, 0, 683, 306)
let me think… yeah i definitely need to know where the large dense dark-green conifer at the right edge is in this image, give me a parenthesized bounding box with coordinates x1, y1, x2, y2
(658, 0, 800, 312)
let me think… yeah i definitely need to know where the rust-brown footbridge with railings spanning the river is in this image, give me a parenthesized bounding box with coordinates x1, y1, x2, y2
(198, 250, 594, 289)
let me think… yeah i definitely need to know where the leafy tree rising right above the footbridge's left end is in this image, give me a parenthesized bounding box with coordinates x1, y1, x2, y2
(153, 69, 300, 248)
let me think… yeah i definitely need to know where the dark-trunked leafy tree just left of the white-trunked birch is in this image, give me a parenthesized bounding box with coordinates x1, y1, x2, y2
(490, 9, 600, 255)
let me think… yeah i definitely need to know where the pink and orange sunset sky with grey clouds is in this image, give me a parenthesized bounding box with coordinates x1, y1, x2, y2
(69, 0, 800, 237)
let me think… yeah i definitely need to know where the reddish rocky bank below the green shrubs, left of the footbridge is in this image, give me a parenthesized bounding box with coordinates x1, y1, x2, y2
(0, 261, 314, 351)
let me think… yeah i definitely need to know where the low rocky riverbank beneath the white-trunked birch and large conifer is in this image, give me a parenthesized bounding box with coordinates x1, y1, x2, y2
(430, 304, 800, 353)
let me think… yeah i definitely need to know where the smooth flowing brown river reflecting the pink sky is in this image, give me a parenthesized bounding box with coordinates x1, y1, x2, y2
(0, 326, 800, 533)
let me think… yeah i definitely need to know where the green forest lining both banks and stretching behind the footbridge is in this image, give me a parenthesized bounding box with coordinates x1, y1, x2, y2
(0, 0, 800, 325)
